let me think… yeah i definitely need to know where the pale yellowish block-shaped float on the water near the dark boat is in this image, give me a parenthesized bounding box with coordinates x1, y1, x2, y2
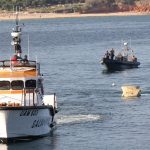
(121, 85, 141, 97)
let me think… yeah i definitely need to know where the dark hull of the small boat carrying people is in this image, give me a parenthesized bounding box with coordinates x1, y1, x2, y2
(102, 58, 140, 70)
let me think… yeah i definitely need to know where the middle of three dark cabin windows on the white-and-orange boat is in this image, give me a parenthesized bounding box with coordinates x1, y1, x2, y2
(11, 80, 24, 90)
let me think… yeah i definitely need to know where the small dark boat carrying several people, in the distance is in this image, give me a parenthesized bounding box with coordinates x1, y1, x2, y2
(101, 43, 140, 71)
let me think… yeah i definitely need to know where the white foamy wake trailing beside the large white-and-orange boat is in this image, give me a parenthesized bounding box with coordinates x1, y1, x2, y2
(57, 114, 103, 125)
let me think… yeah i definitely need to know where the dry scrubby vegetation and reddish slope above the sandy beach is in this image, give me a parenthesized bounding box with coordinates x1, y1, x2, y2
(0, 0, 150, 13)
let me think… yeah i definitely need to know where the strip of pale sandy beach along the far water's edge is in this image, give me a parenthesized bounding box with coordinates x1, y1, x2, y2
(0, 12, 150, 21)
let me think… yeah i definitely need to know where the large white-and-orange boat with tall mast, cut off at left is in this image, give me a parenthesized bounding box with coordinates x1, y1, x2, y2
(0, 13, 57, 143)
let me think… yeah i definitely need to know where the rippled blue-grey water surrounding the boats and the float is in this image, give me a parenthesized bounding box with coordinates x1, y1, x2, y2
(0, 16, 150, 150)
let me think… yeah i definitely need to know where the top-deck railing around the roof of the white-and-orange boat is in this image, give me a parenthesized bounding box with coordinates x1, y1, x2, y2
(0, 60, 39, 68)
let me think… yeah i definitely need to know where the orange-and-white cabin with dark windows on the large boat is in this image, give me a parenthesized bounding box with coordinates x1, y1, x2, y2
(0, 60, 44, 106)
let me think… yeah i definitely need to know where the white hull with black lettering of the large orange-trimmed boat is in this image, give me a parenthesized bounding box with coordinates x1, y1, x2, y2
(0, 106, 54, 143)
